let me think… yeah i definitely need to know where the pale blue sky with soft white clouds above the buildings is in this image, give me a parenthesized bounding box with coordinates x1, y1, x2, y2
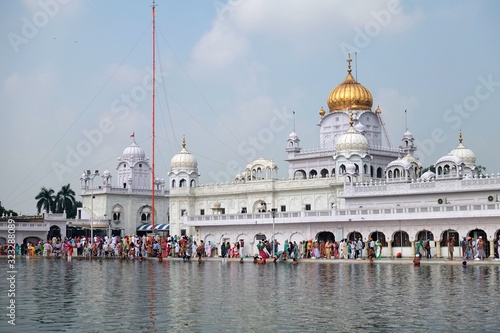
(0, 0, 500, 214)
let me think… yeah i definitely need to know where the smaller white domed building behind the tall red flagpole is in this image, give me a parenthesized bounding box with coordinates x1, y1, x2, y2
(71, 137, 168, 235)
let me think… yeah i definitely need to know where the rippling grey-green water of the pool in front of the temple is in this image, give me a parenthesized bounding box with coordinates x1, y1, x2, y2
(0, 258, 500, 333)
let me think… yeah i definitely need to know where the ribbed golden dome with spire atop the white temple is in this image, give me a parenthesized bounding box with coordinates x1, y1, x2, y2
(328, 54, 373, 112)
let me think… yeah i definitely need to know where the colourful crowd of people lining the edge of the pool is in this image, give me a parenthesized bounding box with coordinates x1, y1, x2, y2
(4, 235, 500, 261)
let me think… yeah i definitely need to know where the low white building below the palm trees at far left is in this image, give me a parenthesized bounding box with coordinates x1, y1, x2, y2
(0, 212, 66, 245)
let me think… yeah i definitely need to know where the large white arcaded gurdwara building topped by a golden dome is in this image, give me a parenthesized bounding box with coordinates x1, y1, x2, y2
(169, 55, 500, 256)
